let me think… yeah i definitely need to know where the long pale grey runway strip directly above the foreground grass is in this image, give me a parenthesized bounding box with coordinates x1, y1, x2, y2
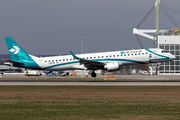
(0, 81, 180, 86)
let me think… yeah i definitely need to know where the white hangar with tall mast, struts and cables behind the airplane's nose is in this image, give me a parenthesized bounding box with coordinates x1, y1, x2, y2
(133, 0, 180, 75)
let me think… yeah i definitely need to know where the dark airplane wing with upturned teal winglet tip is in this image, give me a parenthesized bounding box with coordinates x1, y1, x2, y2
(70, 51, 105, 70)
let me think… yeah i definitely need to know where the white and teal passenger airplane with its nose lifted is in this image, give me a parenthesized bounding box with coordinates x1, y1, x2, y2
(4, 37, 176, 78)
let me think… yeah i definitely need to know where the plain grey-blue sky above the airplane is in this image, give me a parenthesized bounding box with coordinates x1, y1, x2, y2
(0, 0, 180, 55)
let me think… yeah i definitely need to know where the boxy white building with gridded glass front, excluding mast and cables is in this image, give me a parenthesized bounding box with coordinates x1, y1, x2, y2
(158, 30, 180, 75)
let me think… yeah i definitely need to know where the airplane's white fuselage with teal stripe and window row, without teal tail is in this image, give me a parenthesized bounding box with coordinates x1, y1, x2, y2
(31, 48, 176, 71)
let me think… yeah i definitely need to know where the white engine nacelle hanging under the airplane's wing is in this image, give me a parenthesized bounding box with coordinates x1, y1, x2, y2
(104, 62, 119, 72)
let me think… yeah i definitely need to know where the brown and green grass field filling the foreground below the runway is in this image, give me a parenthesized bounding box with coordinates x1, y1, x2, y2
(0, 86, 180, 120)
